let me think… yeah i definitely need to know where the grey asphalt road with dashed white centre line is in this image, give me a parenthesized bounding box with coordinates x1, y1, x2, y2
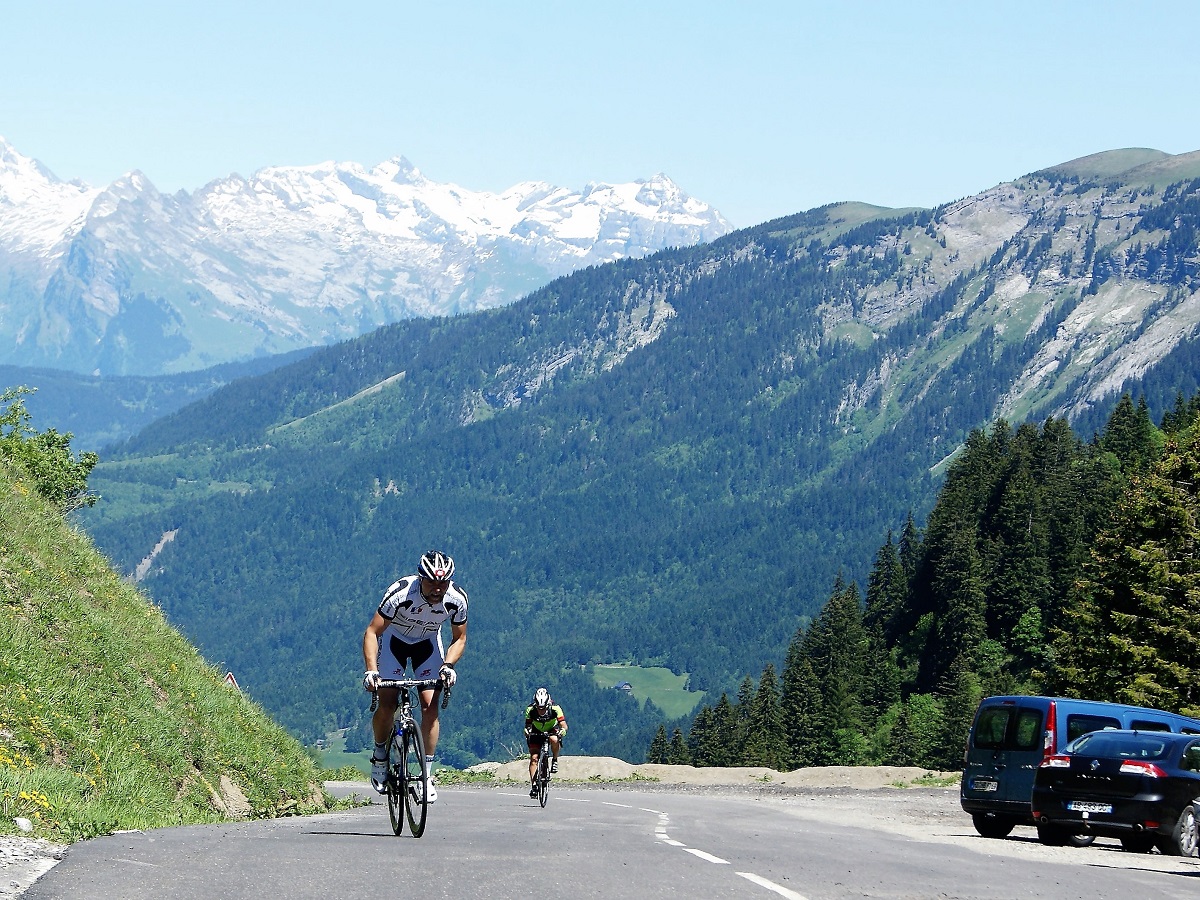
(24, 786, 1200, 900)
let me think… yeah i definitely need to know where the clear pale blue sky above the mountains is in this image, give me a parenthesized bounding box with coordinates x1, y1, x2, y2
(0, 0, 1200, 227)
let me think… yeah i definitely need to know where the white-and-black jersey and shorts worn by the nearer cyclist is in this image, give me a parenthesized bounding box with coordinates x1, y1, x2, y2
(379, 575, 467, 678)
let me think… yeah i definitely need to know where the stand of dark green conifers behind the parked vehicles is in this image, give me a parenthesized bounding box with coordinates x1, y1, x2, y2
(648, 394, 1200, 770)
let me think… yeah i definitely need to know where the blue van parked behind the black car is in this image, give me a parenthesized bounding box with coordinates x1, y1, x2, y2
(959, 696, 1200, 844)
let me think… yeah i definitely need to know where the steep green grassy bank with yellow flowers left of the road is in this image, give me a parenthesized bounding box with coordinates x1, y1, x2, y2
(0, 464, 329, 841)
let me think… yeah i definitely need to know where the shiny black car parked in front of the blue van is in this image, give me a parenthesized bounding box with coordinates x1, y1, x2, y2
(1033, 730, 1200, 857)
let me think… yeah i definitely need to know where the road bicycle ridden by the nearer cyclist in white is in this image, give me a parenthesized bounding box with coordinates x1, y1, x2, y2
(371, 678, 450, 838)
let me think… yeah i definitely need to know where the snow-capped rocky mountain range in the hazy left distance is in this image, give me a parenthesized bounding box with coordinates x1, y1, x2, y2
(0, 138, 732, 374)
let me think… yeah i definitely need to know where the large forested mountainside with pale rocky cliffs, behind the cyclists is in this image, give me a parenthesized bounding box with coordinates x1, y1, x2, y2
(68, 162, 1200, 764)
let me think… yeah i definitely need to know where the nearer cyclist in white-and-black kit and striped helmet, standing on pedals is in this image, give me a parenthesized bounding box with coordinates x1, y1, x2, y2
(362, 550, 467, 803)
